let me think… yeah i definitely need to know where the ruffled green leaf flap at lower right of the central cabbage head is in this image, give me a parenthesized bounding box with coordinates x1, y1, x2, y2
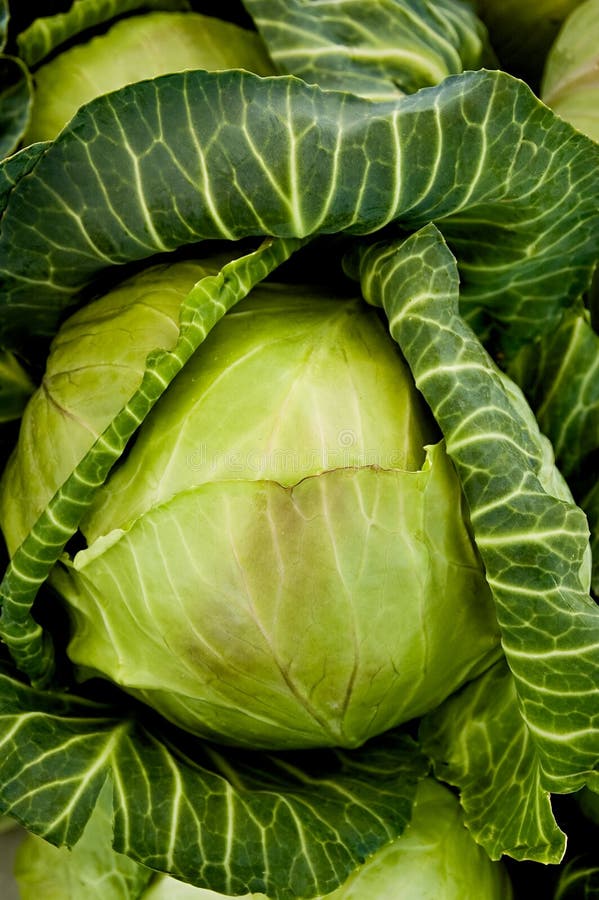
(420, 662, 566, 863)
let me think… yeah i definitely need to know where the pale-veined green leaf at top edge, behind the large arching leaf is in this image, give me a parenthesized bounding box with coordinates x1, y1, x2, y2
(244, 0, 486, 100)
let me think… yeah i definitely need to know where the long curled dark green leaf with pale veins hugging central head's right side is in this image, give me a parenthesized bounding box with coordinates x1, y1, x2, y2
(353, 225, 599, 861)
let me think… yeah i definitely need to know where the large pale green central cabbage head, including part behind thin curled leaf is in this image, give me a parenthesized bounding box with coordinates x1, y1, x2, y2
(0, 263, 501, 748)
